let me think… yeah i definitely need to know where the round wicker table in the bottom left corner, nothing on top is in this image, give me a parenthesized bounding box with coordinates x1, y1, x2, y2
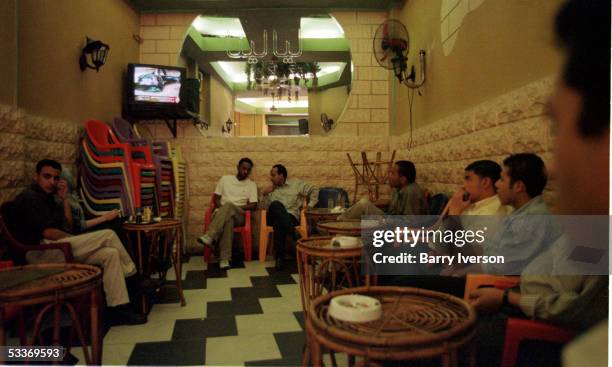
(0, 263, 102, 365)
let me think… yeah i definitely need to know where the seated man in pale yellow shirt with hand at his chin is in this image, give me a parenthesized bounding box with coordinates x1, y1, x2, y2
(429, 160, 512, 255)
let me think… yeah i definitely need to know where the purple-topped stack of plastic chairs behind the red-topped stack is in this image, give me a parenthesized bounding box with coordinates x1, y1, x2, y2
(113, 118, 174, 217)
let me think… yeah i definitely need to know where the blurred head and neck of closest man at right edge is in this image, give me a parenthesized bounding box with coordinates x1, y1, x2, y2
(548, 0, 610, 214)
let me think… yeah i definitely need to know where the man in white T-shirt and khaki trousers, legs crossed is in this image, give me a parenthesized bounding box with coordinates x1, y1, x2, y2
(198, 158, 257, 269)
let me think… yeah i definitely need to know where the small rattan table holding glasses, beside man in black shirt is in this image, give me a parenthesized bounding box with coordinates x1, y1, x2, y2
(123, 219, 186, 312)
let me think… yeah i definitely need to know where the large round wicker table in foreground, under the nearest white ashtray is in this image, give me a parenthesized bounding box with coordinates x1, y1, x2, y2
(306, 286, 476, 366)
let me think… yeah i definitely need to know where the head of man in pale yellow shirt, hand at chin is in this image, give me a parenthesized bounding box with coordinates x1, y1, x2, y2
(463, 160, 501, 203)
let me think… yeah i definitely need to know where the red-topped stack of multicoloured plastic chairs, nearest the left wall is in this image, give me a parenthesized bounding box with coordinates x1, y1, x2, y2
(80, 120, 157, 215)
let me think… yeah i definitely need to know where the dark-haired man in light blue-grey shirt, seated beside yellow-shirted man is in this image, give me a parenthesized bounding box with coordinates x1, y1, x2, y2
(443, 153, 561, 275)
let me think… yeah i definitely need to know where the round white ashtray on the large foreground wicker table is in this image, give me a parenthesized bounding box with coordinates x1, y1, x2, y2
(328, 294, 382, 322)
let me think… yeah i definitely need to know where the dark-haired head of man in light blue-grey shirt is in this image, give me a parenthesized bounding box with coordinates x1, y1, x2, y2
(495, 153, 547, 208)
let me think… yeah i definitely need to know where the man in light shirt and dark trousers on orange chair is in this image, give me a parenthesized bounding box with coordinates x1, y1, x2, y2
(263, 164, 319, 270)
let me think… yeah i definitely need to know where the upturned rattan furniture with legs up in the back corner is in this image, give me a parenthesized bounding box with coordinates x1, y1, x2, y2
(346, 150, 395, 202)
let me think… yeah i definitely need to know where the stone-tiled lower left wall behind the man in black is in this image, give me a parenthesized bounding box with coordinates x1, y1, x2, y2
(0, 105, 81, 206)
